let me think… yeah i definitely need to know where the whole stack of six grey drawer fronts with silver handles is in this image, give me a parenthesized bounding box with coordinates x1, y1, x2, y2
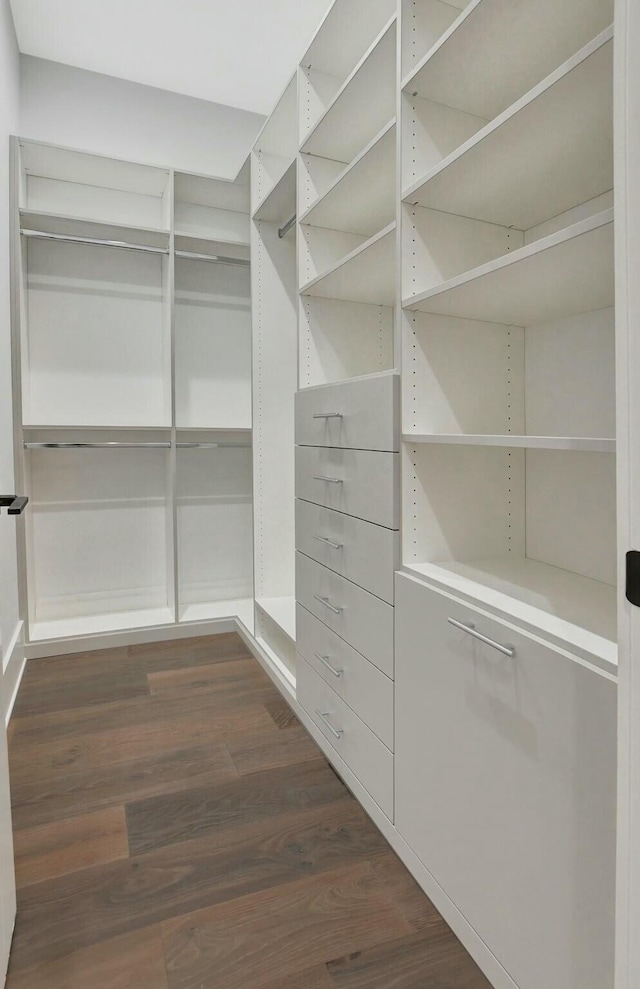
(296, 372, 400, 820)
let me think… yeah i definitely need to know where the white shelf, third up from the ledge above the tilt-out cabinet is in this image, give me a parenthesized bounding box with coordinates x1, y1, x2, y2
(403, 28, 613, 230)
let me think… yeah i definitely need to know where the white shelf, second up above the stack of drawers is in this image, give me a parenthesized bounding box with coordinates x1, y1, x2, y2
(300, 117, 396, 234)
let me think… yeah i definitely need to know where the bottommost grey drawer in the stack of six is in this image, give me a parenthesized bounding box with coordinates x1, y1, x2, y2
(296, 656, 393, 820)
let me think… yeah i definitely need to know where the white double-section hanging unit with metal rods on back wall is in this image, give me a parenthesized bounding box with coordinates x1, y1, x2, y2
(13, 140, 253, 643)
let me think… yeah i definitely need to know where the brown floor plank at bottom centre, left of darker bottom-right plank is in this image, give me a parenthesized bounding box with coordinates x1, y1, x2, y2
(162, 863, 406, 989)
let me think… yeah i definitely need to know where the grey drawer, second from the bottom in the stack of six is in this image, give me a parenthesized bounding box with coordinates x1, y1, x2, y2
(296, 605, 393, 751)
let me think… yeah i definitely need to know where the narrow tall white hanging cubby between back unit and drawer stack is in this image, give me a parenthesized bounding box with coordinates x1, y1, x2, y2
(251, 73, 298, 684)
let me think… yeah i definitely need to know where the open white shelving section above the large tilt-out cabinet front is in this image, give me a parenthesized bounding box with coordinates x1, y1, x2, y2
(401, 0, 616, 663)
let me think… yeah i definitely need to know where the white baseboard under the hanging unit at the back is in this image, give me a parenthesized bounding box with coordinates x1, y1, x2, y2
(24, 618, 238, 659)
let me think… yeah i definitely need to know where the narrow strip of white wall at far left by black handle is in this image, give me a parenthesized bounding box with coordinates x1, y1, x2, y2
(0, 0, 22, 715)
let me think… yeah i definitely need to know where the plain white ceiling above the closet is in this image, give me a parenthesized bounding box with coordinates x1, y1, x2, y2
(11, 0, 331, 114)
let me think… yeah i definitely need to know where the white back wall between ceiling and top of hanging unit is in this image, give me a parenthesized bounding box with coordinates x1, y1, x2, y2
(20, 55, 264, 178)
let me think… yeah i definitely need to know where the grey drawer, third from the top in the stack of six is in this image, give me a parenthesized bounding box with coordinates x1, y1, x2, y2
(296, 500, 400, 604)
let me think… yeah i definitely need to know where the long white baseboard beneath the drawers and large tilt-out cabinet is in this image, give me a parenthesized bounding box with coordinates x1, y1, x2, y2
(239, 629, 519, 989)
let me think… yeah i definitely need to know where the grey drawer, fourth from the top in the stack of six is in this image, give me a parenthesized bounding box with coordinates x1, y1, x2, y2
(296, 553, 393, 670)
